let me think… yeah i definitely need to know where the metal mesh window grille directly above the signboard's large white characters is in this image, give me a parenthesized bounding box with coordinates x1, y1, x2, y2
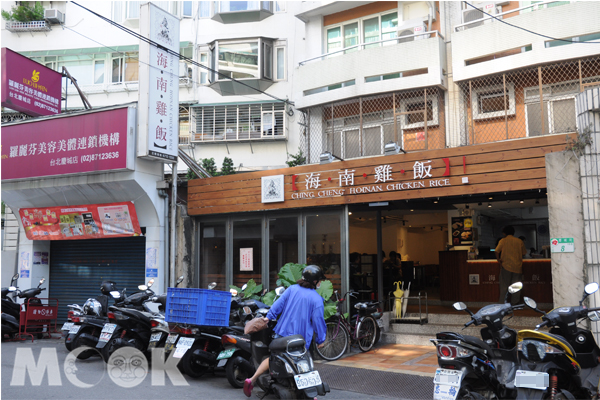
(299, 88, 446, 164)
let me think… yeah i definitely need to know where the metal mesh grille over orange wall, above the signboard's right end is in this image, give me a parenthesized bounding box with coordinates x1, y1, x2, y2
(454, 57, 600, 145)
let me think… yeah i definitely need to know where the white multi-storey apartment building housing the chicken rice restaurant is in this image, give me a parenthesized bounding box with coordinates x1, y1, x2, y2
(2, 1, 600, 328)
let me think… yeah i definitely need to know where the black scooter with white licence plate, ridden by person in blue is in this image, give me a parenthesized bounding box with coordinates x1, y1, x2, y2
(250, 288, 330, 399)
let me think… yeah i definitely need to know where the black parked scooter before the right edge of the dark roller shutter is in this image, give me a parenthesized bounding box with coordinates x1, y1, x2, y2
(96, 279, 156, 362)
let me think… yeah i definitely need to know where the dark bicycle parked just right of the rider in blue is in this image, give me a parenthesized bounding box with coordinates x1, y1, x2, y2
(316, 290, 379, 361)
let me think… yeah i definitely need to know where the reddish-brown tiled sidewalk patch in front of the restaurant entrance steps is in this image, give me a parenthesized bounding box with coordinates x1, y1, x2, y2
(316, 344, 438, 377)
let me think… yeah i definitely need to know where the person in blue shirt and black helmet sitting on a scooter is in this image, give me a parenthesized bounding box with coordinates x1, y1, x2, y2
(244, 265, 327, 397)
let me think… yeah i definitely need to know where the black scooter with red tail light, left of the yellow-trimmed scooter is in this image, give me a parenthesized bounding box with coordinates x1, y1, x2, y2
(431, 282, 524, 399)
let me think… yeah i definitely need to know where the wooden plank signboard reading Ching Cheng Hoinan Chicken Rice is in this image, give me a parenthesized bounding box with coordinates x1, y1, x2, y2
(188, 135, 566, 215)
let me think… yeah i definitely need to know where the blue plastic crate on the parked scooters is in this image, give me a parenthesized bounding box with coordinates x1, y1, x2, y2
(165, 288, 231, 326)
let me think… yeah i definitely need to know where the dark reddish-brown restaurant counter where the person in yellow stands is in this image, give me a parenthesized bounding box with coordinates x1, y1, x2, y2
(440, 250, 552, 304)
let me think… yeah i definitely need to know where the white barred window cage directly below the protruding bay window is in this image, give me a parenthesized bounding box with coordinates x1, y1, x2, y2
(191, 103, 287, 142)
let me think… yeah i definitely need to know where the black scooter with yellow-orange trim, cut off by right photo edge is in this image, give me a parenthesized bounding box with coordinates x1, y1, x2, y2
(515, 283, 600, 399)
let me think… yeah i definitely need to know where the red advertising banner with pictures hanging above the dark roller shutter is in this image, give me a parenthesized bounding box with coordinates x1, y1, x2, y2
(19, 201, 142, 239)
